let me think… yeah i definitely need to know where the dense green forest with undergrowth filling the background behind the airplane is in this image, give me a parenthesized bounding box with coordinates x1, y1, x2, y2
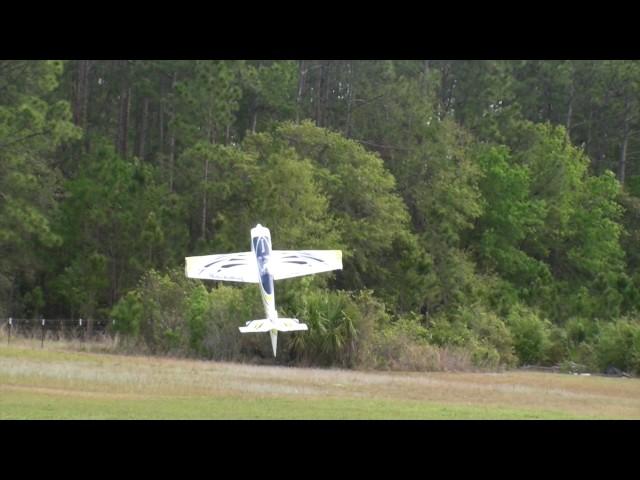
(0, 60, 640, 372)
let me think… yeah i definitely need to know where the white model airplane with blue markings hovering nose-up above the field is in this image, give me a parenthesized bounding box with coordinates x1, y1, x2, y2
(185, 224, 342, 357)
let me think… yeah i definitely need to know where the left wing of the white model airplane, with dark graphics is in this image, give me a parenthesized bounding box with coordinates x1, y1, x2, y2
(185, 252, 260, 283)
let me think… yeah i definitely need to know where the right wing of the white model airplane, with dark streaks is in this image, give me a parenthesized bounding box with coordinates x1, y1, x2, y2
(270, 250, 342, 280)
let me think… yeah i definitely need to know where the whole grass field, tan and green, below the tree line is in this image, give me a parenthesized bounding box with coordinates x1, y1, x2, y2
(0, 340, 640, 419)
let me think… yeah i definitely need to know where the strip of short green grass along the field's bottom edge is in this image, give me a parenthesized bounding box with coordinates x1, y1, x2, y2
(0, 390, 575, 420)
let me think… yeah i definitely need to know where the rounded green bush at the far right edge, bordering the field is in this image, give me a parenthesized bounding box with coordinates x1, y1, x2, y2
(595, 319, 640, 373)
